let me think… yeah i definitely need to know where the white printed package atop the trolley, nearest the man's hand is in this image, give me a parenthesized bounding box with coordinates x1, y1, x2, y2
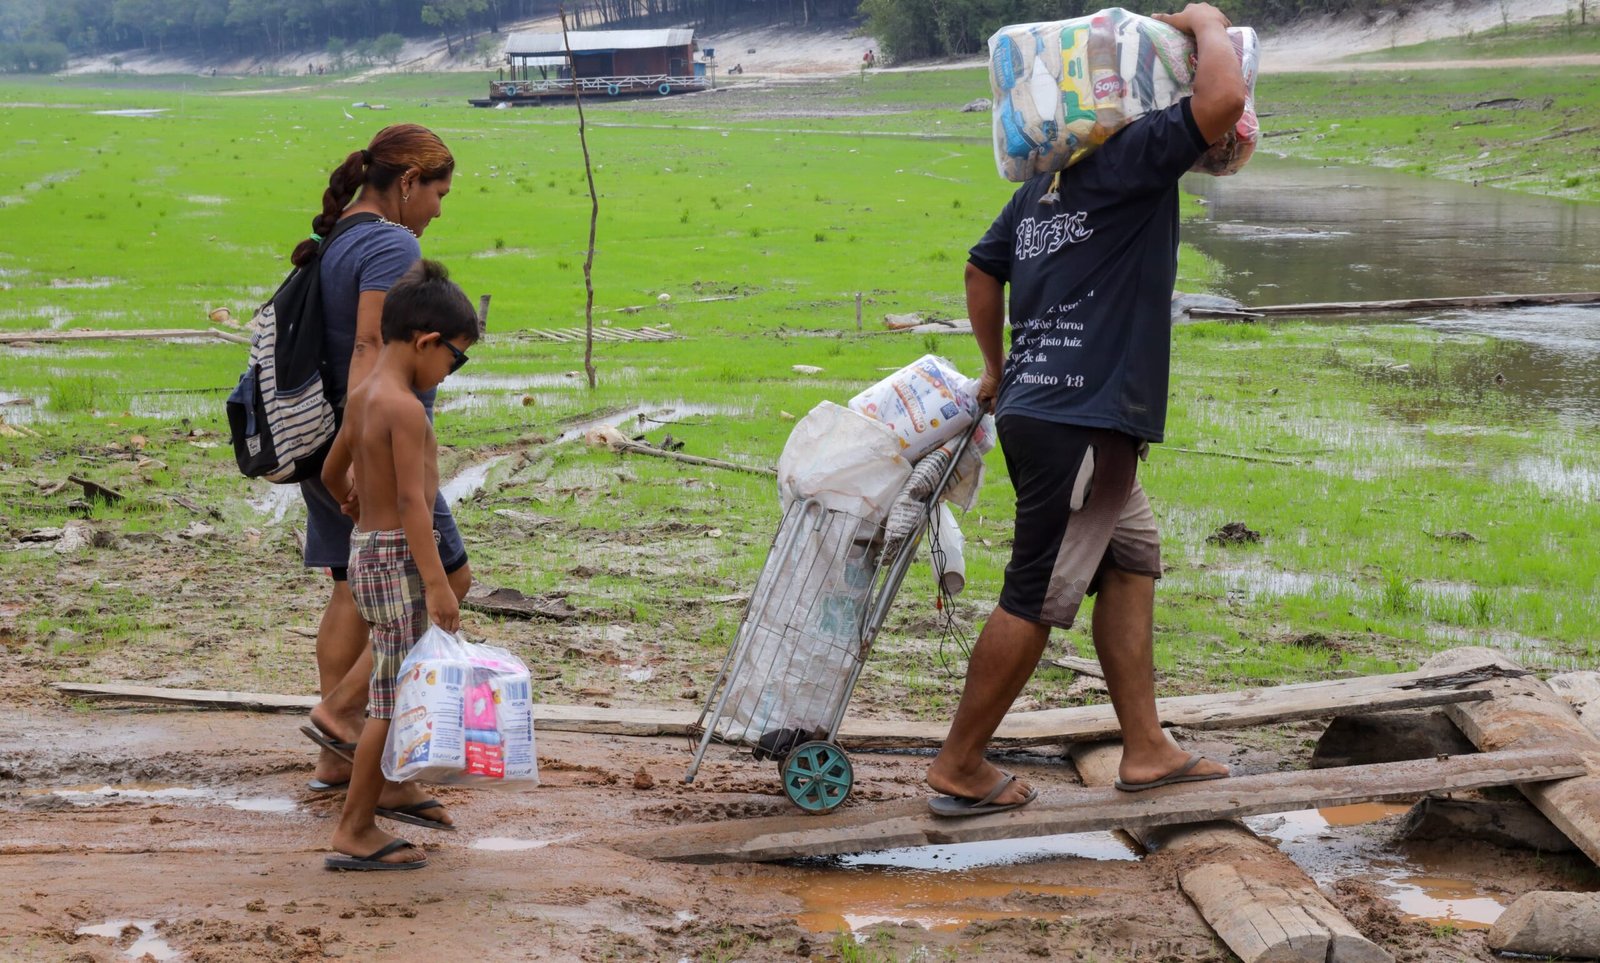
(850, 355, 994, 462)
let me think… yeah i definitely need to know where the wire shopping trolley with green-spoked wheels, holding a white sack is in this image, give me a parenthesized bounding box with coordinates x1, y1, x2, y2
(683, 422, 979, 813)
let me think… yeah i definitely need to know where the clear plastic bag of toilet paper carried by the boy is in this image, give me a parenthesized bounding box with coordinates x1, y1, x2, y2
(382, 625, 539, 789)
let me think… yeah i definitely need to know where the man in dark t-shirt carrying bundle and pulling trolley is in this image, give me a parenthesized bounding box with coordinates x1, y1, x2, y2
(928, 3, 1246, 816)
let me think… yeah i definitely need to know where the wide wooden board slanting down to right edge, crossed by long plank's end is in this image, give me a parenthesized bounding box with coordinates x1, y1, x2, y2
(1422, 648, 1600, 862)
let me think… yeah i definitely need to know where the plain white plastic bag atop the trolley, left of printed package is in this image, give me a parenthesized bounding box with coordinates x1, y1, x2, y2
(778, 402, 910, 521)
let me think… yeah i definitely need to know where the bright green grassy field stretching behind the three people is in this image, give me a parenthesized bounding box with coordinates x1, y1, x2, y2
(0, 63, 1600, 700)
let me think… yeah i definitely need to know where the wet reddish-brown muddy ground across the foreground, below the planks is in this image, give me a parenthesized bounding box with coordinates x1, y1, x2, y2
(0, 691, 1571, 961)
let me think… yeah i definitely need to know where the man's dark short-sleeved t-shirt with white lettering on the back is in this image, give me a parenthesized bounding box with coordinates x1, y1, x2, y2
(968, 98, 1206, 442)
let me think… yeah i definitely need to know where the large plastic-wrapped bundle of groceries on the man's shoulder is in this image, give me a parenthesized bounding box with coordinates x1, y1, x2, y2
(989, 6, 1261, 181)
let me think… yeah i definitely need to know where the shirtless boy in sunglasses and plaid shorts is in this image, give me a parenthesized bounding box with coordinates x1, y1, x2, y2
(322, 261, 478, 870)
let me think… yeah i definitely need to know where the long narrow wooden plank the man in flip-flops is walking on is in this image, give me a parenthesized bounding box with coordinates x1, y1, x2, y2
(621, 749, 1586, 862)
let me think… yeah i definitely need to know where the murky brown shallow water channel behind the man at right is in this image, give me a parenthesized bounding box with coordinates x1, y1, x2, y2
(1184, 155, 1600, 424)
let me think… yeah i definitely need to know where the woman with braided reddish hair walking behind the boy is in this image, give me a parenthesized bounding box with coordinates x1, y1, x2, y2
(291, 123, 472, 827)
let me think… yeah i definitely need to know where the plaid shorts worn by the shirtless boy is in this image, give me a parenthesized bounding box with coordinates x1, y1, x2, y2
(350, 529, 427, 718)
